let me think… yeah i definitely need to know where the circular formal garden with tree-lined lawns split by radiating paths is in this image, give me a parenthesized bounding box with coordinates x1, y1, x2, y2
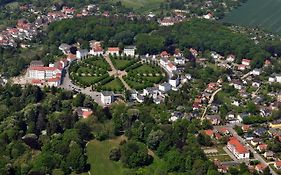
(70, 56, 166, 92)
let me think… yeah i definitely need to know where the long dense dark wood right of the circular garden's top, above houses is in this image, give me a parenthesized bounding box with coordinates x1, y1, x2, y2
(136, 19, 270, 67)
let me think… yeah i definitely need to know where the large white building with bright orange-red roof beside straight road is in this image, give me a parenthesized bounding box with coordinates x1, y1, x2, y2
(227, 137, 250, 159)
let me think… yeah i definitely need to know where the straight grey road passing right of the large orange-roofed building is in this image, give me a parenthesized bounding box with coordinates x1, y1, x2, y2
(214, 125, 278, 175)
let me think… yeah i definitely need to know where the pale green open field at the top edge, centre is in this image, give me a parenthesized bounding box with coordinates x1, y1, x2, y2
(111, 0, 165, 12)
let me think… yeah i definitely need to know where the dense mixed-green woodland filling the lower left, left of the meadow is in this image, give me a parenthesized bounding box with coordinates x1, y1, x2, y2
(0, 85, 102, 174)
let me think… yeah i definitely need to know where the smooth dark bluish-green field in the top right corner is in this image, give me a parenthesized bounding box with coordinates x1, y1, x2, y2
(223, 0, 281, 34)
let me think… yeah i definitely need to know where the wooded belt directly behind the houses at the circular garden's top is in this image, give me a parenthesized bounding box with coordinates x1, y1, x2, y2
(47, 16, 158, 47)
